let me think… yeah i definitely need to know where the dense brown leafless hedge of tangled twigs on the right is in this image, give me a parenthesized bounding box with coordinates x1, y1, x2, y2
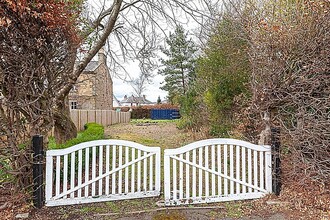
(231, 0, 330, 184)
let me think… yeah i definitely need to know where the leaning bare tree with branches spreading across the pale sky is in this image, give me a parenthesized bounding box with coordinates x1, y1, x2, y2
(55, 0, 212, 140)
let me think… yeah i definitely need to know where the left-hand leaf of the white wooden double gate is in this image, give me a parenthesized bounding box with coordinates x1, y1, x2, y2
(45, 140, 161, 206)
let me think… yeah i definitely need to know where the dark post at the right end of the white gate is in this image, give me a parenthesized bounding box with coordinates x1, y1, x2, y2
(271, 128, 282, 196)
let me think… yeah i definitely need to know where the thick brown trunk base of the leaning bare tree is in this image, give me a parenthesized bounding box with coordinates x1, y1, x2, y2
(54, 98, 77, 144)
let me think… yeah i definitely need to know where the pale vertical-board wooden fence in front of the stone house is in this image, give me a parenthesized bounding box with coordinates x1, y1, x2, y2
(71, 110, 131, 131)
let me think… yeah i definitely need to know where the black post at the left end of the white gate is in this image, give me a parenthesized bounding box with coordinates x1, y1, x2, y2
(32, 135, 44, 209)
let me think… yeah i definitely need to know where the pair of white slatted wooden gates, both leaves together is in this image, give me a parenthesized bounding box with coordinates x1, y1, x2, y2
(46, 139, 272, 206)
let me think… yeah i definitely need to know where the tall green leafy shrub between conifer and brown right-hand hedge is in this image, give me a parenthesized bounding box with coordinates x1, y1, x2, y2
(198, 18, 250, 137)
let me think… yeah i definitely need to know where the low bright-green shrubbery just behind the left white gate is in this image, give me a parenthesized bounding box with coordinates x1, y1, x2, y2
(48, 123, 104, 149)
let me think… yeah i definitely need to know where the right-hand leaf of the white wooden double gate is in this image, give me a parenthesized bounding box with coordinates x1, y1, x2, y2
(164, 139, 272, 206)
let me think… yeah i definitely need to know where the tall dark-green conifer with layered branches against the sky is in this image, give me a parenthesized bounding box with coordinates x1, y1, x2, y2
(158, 26, 197, 103)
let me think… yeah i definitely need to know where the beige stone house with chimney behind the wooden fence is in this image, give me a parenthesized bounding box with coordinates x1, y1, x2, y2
(69, 49, 113, 110)
